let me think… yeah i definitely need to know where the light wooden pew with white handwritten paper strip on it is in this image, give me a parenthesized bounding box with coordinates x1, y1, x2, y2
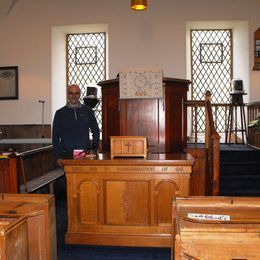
(172, 197, 260, 260)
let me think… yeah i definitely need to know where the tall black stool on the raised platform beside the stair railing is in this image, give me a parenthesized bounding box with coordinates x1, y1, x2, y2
(225, 92, 247, 145)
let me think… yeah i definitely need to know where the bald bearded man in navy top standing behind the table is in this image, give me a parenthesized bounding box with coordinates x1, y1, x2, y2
(52, 85, 99, 159)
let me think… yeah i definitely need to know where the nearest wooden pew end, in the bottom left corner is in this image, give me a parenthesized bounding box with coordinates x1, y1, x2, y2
(0, 214, 28, 260)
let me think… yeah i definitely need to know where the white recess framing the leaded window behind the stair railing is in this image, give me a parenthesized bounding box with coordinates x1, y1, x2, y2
(186, 21, 250, 140)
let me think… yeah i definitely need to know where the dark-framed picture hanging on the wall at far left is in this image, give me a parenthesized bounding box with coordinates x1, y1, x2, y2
(0, 66, 18, 100)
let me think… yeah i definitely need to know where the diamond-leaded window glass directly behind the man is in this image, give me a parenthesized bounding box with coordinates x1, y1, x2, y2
(67, 32, 106, 130)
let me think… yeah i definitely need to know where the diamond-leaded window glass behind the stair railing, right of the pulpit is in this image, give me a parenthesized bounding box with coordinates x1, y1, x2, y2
(191, 30, 232, 133)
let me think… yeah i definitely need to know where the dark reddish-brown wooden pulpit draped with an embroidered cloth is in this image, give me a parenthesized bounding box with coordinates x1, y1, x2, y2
(98, 78, 190, 153)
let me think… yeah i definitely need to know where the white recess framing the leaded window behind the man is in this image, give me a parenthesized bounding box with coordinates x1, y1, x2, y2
(51, 24, 108, 119)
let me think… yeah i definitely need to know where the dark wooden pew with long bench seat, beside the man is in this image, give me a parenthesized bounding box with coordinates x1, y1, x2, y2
(0, 145, 64, 193)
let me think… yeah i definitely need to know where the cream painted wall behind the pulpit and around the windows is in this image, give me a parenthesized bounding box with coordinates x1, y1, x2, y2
(0, 0, 260, 124)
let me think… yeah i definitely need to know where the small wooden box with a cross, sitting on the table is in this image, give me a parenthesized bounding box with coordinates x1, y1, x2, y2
(110, 136, 147, 158)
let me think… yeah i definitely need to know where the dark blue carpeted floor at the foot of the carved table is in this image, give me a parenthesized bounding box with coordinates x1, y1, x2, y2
(56, 191, 171, 260)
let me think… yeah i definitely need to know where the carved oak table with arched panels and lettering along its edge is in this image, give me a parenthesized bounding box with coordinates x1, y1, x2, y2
(62, 153, 194, 247)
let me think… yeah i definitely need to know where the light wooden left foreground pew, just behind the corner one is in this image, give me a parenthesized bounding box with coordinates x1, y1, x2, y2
(0, 193, 57, 260)
